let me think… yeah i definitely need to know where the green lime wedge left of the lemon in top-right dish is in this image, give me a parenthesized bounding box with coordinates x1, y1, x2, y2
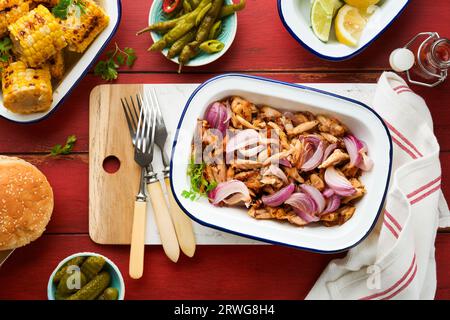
(311, 0, 336, 42)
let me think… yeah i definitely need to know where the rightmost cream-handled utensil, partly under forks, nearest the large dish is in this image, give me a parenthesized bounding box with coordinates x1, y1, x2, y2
(150, 88, 196, 257)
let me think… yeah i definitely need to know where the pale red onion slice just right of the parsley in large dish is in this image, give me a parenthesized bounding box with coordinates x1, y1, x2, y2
(208, 180, 251, 206)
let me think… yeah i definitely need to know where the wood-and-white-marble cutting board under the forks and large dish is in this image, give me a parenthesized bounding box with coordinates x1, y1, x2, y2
(89, 84, 375, 244)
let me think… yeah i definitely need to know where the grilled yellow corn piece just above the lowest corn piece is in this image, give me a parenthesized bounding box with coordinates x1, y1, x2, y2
(8, 5, 67, 68)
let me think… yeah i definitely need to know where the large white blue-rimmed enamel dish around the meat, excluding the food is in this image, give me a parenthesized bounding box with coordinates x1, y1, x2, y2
(170, 74, 392, 253)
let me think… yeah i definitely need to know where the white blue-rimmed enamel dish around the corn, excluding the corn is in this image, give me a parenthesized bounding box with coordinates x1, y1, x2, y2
(0, 0, 122, 124)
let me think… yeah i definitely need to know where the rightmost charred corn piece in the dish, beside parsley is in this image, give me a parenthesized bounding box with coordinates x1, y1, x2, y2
(60, 0, 109, 53)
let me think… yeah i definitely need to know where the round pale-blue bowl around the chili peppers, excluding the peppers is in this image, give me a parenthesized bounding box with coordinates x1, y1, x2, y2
(148, 0, 237, 67)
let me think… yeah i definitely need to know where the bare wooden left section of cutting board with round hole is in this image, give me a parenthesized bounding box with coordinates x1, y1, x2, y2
(89, 85, 142, 244)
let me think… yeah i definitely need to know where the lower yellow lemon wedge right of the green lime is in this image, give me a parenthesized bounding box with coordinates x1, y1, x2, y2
(334, 4, 367, 47)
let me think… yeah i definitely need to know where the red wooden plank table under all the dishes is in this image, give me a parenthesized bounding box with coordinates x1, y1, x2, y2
(0, 0, 450, 299)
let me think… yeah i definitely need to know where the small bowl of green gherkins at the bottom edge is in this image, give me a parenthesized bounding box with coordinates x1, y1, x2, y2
(47, 252, 125, 300)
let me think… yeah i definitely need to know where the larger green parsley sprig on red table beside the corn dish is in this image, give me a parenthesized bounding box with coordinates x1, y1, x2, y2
(94, 43, 137, 81)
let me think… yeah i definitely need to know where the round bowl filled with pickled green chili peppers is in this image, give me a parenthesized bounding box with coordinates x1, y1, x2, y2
(141, 0, 246, 72)
